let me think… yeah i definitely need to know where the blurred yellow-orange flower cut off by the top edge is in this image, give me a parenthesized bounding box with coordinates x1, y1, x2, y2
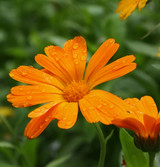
(116, 0, 147, 20)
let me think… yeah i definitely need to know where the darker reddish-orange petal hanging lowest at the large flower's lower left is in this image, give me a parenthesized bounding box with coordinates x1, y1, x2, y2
(24, 109, 52, 139)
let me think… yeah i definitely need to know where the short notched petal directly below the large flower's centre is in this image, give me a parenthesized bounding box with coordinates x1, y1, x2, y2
(52, 102, 78, 129)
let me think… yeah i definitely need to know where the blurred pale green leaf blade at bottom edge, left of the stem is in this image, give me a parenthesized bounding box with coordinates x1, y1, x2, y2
(45, 154, 71, 167)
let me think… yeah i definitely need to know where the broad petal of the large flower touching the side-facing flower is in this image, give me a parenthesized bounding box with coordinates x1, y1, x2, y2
(82, 90, 128, 120)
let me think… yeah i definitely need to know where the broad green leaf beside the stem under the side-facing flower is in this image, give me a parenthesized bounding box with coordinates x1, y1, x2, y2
(120, 129, 148, 167)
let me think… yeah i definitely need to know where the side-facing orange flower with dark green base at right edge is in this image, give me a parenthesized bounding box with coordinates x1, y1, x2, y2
(112, 96, 160, 152)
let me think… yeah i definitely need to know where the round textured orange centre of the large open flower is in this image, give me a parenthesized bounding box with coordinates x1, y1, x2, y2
(63, 81, 89, 102)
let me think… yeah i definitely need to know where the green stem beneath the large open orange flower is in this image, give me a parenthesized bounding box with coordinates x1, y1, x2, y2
(93, 123, 106, 167)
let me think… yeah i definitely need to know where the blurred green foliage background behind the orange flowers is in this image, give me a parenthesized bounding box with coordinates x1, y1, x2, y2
(0, 0, 160, 167)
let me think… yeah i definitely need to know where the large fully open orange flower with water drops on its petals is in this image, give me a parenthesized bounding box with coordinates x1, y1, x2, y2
(7, 37, 136, 138)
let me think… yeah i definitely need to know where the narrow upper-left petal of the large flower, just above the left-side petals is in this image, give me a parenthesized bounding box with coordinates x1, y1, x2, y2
(35, 53, 70, 83)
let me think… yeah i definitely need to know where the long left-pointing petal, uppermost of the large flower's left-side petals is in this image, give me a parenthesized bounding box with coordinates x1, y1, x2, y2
(9, 66, 64, 90)
